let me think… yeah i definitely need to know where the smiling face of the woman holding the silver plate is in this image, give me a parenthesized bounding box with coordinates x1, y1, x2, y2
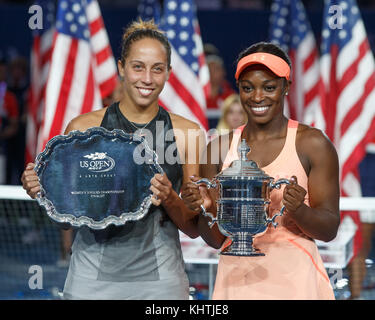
(118, 38, 170, 107)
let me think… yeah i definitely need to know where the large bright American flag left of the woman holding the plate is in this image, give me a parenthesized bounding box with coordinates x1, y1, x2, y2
(38, 0, 117, 150)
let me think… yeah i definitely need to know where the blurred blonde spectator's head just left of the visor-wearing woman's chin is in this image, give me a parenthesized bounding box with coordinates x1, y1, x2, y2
(216, 93, 247, 134)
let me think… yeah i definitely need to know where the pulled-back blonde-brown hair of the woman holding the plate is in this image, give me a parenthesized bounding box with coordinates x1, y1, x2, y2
(121, 18, 171, 68)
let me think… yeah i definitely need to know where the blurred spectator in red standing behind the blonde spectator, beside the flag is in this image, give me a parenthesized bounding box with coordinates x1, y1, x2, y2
(205, 47, 235, 109)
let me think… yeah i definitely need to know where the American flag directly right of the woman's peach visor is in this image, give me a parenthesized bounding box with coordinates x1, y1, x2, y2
(269, 0, 321, 125)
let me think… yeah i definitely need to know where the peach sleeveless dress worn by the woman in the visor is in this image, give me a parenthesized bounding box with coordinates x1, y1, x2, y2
(213, 120, 335, 300)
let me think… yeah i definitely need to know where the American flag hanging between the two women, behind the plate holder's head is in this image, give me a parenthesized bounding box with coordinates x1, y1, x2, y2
(140, 0, 209, 129)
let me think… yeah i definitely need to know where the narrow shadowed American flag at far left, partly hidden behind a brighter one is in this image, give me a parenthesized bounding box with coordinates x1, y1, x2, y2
(25, 0, 56, 163)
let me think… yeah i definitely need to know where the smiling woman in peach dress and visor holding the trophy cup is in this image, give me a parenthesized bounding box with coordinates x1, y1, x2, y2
(182, 42, 340, 300)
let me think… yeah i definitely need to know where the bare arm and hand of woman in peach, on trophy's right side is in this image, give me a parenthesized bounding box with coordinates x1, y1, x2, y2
(283, 128, 340, 241)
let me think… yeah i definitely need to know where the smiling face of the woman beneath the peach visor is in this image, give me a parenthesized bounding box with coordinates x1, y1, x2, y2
(238, 65, 289, 124)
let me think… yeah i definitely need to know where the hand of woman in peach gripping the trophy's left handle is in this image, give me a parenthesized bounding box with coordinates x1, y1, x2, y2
(181, 176, 212, 212)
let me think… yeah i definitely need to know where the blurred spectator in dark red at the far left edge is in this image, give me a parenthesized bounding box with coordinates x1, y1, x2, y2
(0, 58, 19, 184)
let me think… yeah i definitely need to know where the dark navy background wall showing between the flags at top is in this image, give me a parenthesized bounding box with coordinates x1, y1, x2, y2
(0, 1, 375, 89)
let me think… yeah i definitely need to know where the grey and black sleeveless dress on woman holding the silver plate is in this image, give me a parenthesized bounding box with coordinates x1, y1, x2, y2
(64, 103, 189, 300)
